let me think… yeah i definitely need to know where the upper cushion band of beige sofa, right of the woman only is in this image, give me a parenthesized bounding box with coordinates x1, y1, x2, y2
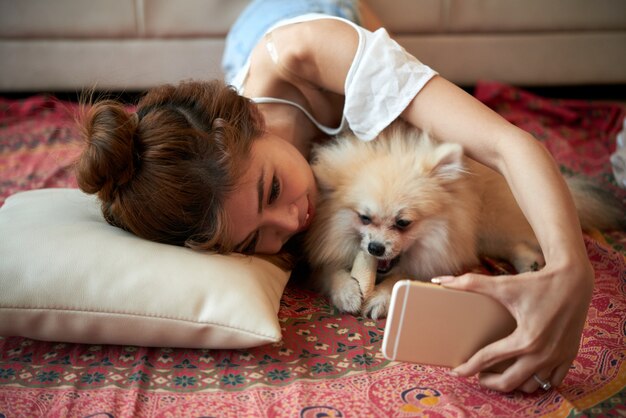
(367, 0, 626, 34)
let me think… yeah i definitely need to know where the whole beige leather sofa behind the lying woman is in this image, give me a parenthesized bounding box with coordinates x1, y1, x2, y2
(0, 0, 626, 92)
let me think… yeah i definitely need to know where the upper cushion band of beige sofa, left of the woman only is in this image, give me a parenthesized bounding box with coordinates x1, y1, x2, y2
(0, 0, 248, 39)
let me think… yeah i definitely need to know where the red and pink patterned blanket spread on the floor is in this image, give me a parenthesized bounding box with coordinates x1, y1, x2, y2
(0, 83, 626, 417)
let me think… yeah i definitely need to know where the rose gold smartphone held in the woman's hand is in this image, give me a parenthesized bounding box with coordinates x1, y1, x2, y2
(382, 280, 516, 367)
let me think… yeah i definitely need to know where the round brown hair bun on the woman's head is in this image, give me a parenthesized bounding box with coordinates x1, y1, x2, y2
(76, 100, 139, 202)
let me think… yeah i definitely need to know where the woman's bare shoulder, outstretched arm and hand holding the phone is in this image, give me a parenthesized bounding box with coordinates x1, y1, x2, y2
(274, 20, 593, 391)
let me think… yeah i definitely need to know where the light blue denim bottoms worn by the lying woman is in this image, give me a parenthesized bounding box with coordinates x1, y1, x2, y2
(222, 0, 360, 83)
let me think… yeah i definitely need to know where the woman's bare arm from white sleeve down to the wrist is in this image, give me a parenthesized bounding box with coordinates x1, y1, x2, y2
(403, 77, 586, 264)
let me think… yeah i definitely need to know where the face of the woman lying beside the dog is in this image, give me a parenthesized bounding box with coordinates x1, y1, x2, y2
(225, 133, 317, 254)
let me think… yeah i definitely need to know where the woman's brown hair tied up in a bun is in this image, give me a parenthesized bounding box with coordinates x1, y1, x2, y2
(76, 81, 263, 252)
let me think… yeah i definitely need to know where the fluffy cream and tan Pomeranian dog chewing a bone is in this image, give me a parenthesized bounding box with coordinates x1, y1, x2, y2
(304, 122, 625, 318)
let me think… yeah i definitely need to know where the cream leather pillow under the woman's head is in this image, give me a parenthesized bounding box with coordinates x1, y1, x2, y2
(0, 189, 289, 348)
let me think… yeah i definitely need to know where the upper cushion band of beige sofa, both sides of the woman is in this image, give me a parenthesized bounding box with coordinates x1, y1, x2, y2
(0, 0, 626, 38)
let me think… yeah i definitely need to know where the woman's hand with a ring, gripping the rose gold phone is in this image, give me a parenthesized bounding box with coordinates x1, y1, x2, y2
(432, 258, 593, 393)
